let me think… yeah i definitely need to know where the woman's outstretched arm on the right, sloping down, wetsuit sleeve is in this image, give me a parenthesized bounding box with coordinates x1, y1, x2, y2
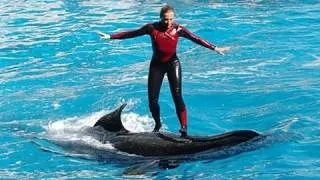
(178, 26, 230, 55)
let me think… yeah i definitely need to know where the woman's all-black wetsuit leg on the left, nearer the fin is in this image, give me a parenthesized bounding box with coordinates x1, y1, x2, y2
(148, 62, 166, 132)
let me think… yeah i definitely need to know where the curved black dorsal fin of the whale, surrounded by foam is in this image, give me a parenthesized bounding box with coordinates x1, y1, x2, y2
(94, 104, 127, 132)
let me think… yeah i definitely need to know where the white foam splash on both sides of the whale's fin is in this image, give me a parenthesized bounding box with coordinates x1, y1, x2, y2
(45, 108, 154, 149)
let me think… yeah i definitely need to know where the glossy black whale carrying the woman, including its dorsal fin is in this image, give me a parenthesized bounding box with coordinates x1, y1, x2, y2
(94, 104, 261, 157)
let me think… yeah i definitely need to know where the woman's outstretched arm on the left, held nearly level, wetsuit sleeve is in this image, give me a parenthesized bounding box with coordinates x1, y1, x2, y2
(98, 25, 148, 39)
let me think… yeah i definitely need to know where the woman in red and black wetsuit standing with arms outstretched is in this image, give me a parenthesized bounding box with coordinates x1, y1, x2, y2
(99, 5, 230, 137)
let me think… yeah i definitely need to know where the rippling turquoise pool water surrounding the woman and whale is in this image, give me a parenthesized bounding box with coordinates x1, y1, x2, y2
(0, 0, 320, 179)
